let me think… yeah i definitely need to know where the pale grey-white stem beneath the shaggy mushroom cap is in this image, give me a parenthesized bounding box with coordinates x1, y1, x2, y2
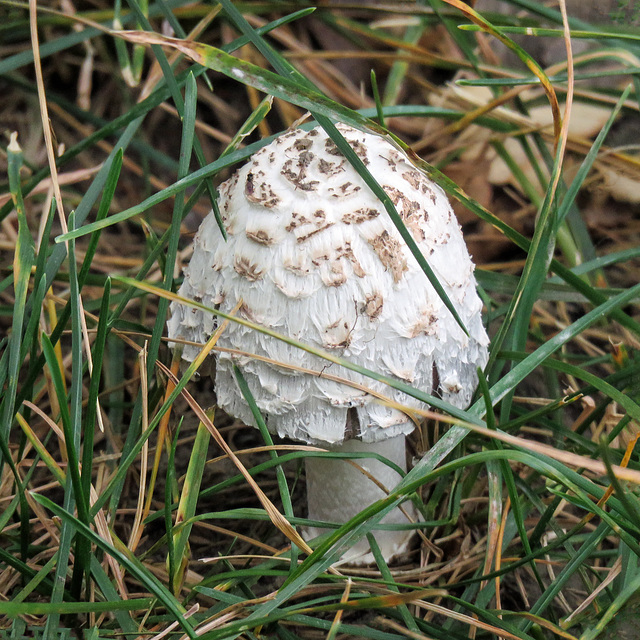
(303, 435, 415, 565)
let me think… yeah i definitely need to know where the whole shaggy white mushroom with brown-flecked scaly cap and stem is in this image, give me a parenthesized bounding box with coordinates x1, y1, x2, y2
(168, 124, 488, 563)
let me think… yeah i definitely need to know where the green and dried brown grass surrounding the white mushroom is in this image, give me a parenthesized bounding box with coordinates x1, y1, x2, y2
(0, 0, 640, 640)
